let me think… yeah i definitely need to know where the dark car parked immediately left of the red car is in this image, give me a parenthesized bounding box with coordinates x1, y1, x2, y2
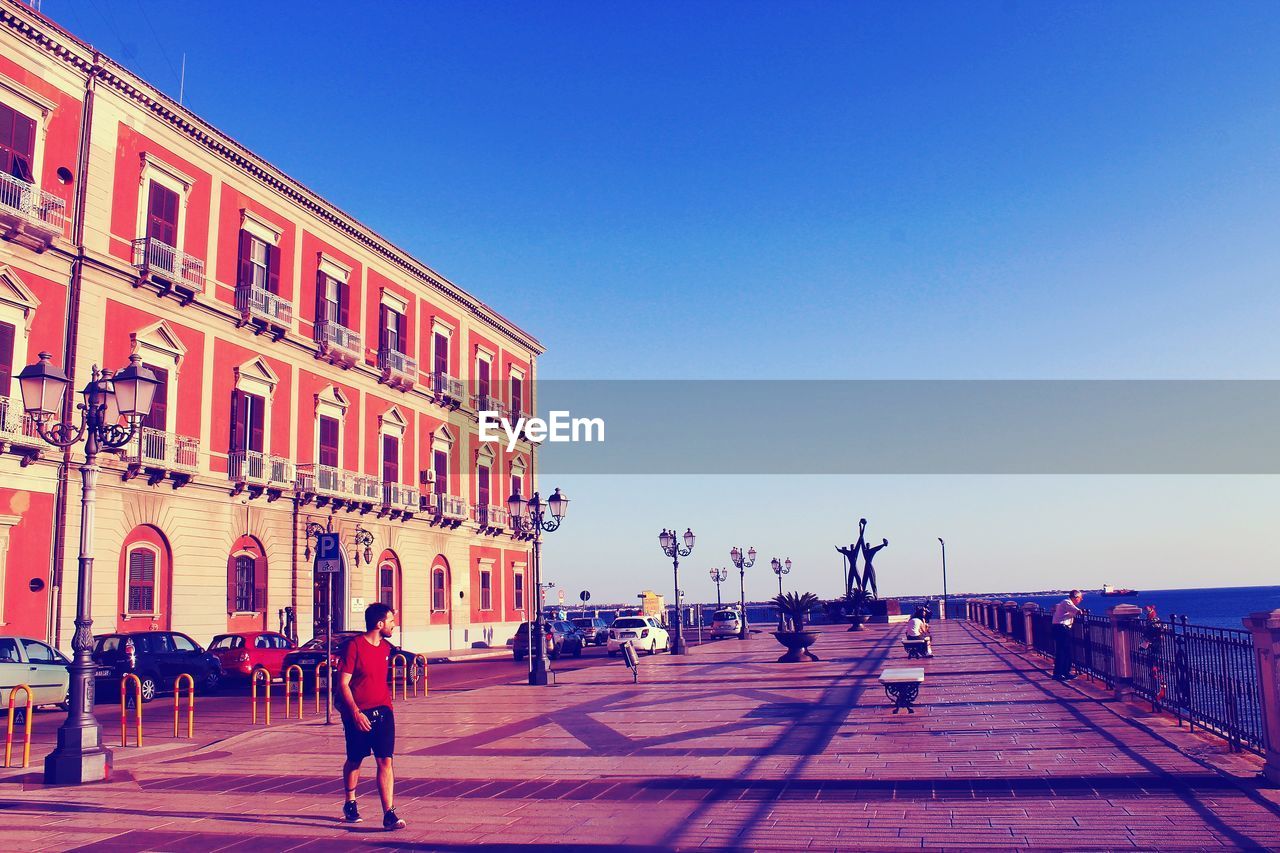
(92, 631, 223, 702)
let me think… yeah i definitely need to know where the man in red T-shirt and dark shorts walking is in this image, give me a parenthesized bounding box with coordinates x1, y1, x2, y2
(338, 602, 404, 830)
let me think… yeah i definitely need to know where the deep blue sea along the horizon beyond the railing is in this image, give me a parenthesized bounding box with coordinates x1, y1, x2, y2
(965, 587, 1280, 629)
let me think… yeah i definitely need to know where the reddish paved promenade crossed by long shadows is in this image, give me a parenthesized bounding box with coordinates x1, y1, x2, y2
(0, 621, 1280, 852)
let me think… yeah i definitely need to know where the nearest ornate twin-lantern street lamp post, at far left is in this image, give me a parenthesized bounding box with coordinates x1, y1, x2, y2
(18, 352, 160, 785)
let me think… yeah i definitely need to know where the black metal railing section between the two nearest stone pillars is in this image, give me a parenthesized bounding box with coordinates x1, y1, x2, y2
(1126, 616, 1266, 753)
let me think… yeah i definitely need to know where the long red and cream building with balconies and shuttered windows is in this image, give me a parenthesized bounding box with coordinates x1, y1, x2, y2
(0, 0, 541, 651)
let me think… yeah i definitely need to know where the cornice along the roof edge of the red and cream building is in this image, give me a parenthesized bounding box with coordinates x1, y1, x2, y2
(0, 0, 544, 355)
